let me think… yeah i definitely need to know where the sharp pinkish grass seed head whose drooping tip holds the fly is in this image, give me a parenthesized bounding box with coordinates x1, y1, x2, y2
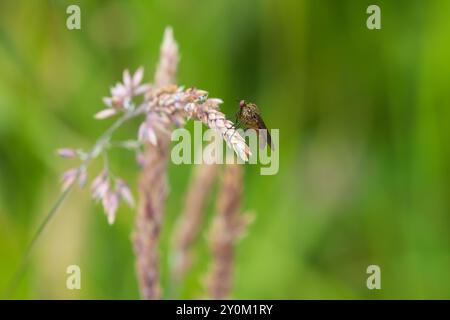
(58, 28, 250, 226)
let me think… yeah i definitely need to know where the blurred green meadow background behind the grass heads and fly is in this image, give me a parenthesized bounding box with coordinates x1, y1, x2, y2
(0, 0, 450, 299)
